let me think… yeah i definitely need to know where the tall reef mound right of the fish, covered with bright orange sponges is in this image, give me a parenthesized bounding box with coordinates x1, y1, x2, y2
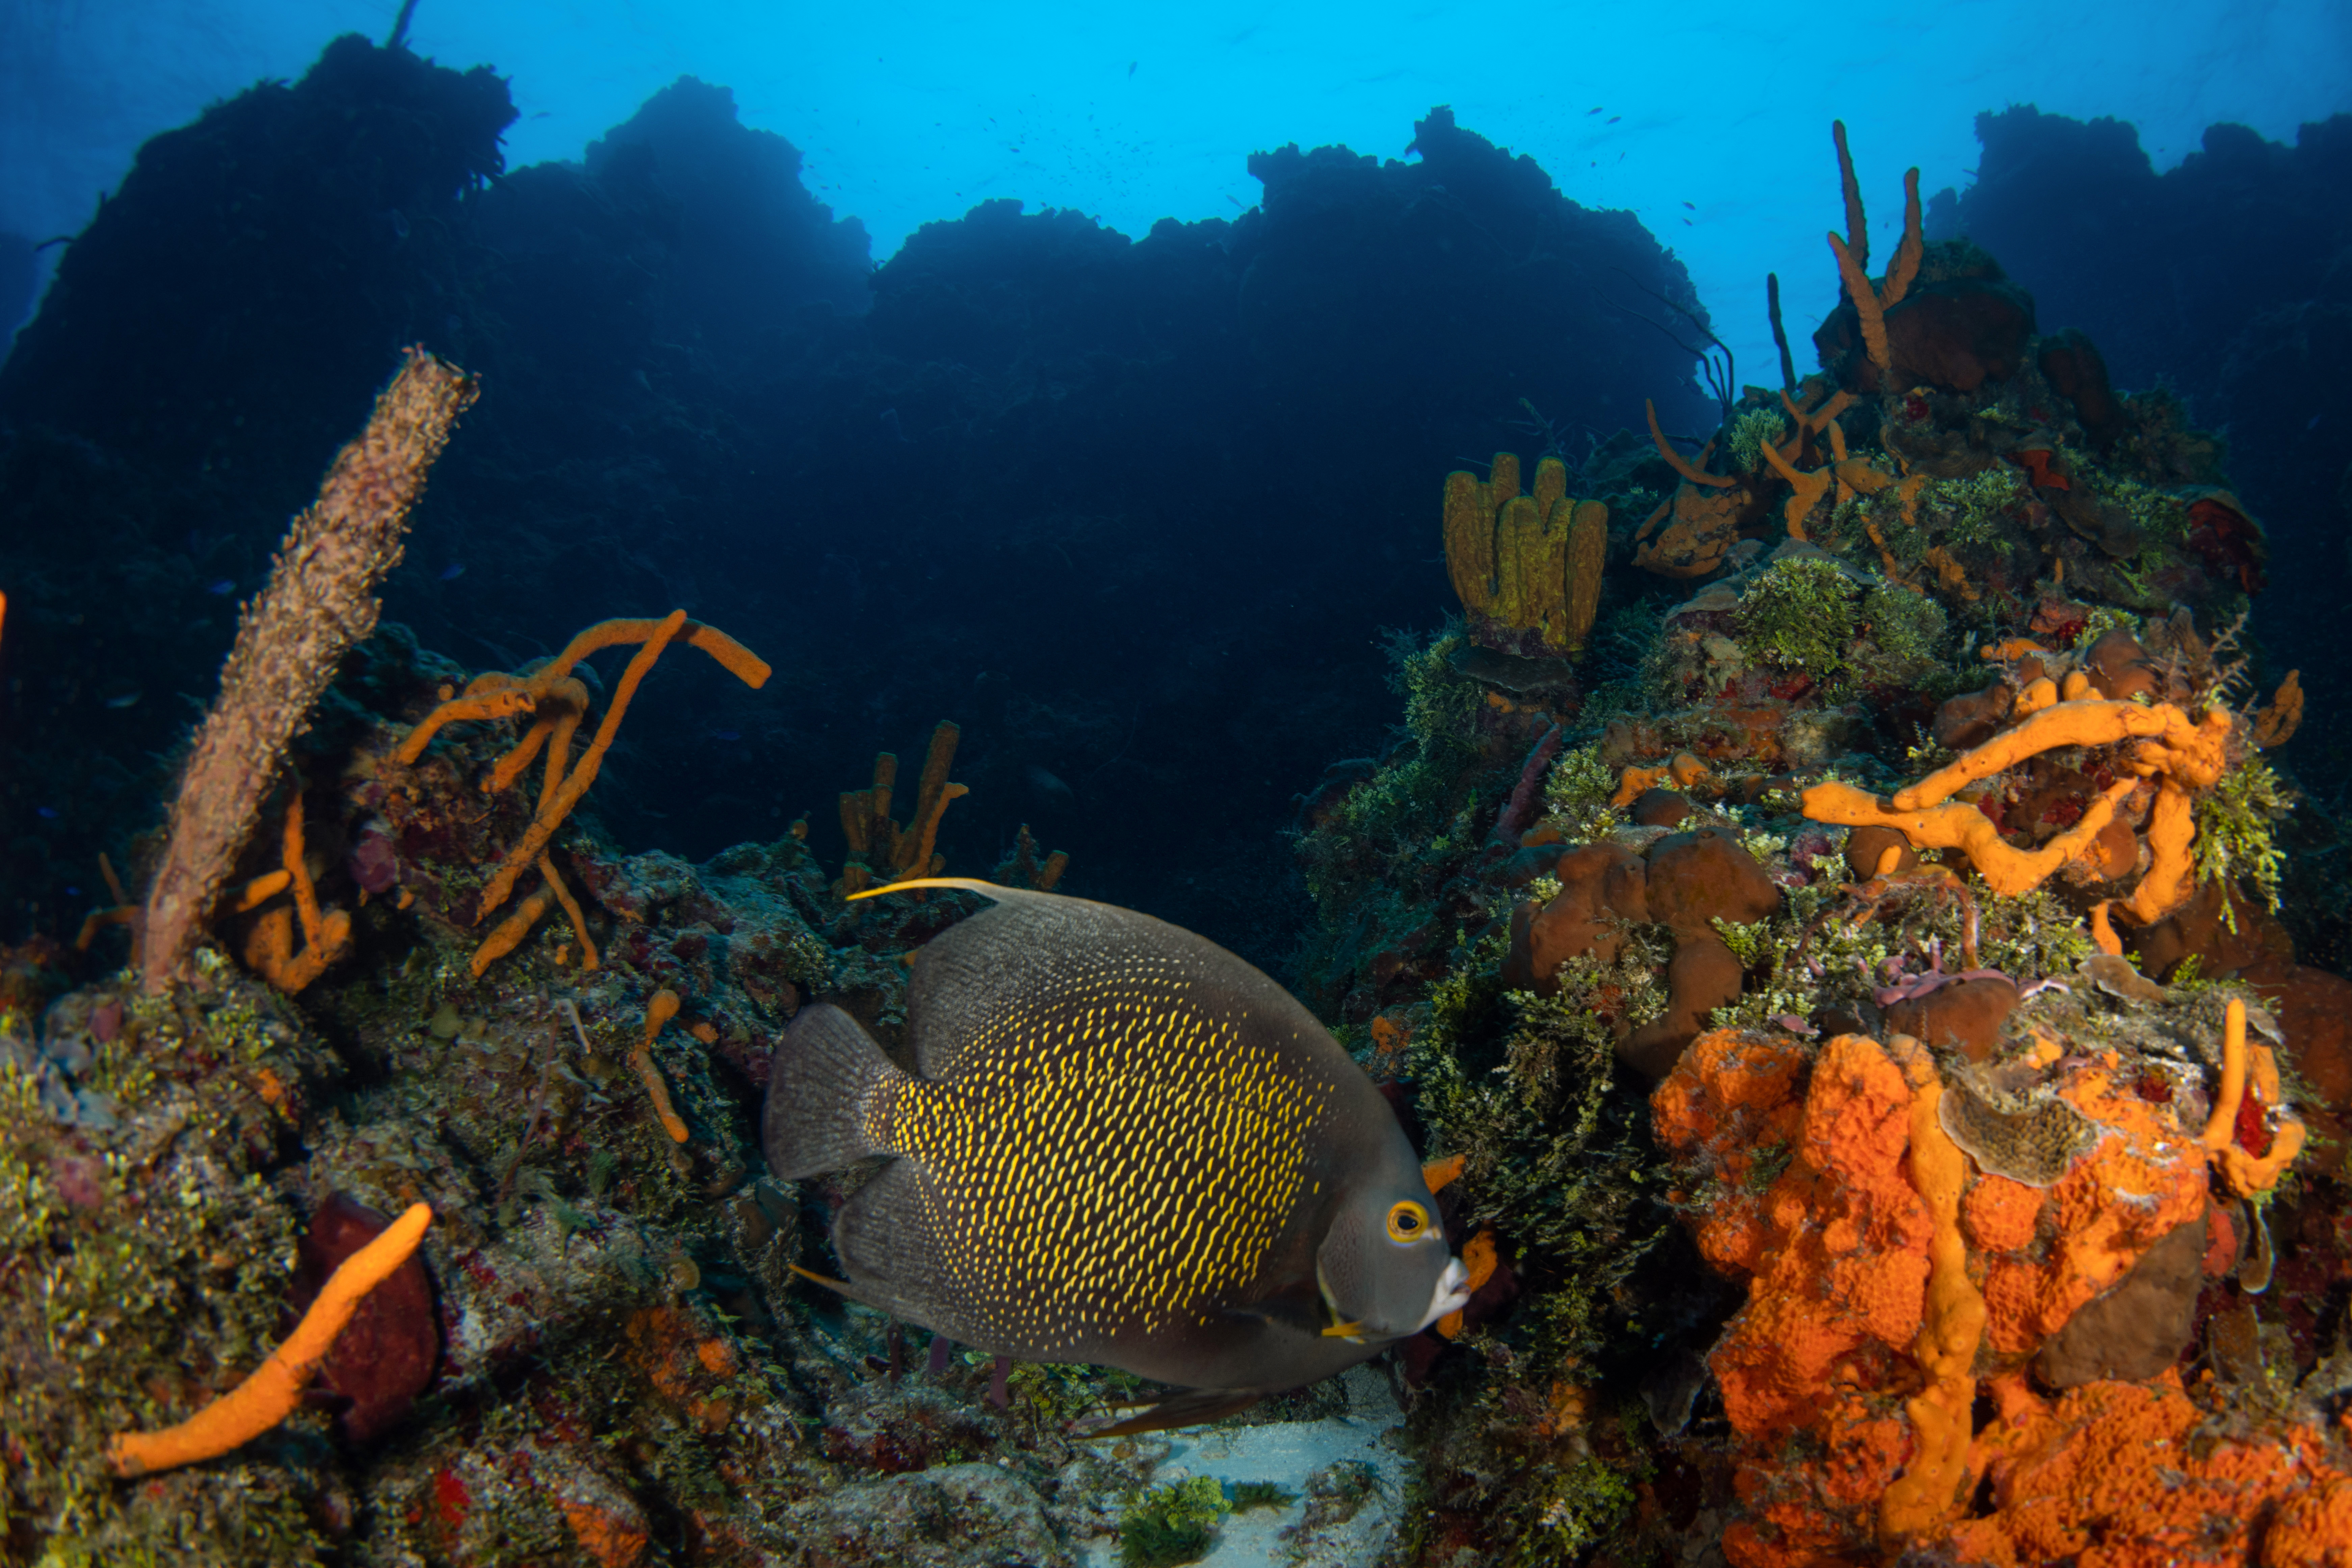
(1301, 134, 2352, 1568)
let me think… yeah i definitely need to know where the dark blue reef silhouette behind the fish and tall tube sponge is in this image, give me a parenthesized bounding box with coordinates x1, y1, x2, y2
(0, 37, 1707, 957)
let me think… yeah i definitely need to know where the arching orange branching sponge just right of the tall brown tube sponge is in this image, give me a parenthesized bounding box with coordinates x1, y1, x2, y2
(393, 609, 772, 975)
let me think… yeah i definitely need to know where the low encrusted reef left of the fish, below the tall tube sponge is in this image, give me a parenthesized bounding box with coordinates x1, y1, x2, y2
(0, 628, 1364, 1566)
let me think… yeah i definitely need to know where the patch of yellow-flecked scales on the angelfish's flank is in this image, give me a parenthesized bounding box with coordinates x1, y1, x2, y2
(868, 955, 1334, 1352)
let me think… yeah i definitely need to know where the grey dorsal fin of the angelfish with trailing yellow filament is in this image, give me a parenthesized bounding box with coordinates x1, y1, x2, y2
(861, 877, 1345, 1081)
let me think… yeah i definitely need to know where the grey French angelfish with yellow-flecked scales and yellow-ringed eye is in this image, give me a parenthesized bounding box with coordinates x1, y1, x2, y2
(762, 877, 1465, 1434)
